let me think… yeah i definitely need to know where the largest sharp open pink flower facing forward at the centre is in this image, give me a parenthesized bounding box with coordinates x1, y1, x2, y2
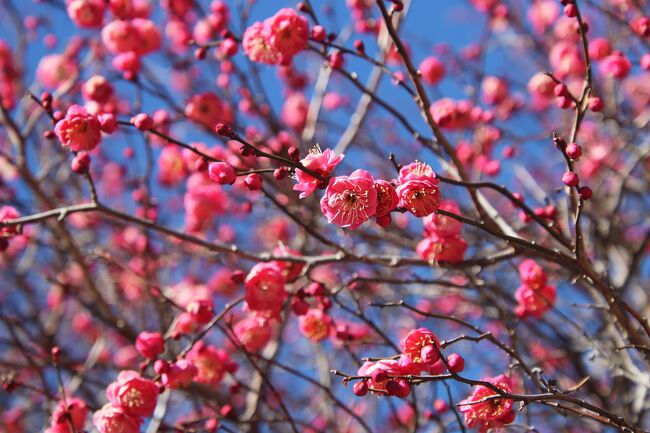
(320, 170, 377, 229)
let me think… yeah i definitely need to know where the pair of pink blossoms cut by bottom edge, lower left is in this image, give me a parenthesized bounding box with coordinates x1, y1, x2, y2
(93, 371, 159, 433)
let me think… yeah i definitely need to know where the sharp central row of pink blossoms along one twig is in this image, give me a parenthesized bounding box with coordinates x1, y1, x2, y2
(302, 155, 440, 229)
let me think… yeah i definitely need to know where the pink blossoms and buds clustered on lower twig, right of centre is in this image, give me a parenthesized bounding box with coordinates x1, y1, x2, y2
(353, 328, 465, 398)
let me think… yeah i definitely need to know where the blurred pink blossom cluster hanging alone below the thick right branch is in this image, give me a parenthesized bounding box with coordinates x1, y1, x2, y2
(515, 259, 557, 318)
